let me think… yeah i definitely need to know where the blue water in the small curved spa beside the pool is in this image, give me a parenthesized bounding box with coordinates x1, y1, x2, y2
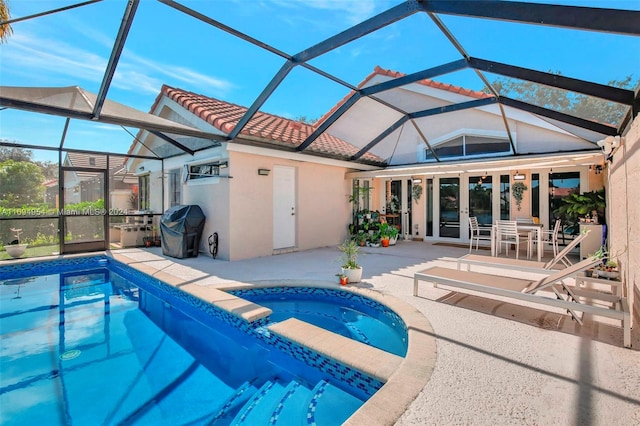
(230, 287, 407, 357)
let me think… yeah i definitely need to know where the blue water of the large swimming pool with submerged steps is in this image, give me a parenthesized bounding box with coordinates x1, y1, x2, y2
(0, 257, 382, 425)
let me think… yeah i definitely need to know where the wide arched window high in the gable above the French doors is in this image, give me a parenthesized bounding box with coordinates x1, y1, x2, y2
(424, 134, 511, 160)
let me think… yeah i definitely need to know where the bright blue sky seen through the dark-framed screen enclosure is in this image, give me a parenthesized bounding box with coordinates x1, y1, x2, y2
(0, 0, 640, 161)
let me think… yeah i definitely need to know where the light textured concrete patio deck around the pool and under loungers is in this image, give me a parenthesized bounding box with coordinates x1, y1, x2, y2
(113, 241, 640, 425)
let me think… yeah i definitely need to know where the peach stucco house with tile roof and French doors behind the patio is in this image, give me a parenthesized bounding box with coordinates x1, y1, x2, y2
(127, 67, 603, 260)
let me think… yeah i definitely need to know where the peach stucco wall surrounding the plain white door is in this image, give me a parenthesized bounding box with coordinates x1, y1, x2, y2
(228, 152, 351, 260)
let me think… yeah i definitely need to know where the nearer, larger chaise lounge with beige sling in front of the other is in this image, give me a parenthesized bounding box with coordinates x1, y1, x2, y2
(413, 257, 631, 348)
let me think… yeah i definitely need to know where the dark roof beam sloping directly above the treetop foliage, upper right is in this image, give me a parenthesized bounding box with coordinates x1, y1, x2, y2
(469, 58, 633, 105)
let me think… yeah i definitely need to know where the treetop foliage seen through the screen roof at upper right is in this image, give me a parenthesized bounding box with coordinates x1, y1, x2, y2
(483, 71, 640, 125)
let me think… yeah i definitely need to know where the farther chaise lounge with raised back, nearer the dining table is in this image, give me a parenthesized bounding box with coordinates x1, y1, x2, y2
(458, 229, 589, 274)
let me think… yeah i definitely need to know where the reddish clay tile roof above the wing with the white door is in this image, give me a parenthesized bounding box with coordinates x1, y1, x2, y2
(157, 85, 384, 164)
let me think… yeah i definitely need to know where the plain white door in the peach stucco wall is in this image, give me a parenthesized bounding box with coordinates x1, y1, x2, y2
(273, 166, 296, 249)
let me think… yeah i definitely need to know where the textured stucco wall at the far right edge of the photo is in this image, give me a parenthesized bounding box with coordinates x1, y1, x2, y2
(607, 116, 640, 323)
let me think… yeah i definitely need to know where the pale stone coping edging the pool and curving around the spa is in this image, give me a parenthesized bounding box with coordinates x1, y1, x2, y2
(3, 252, 437, 425)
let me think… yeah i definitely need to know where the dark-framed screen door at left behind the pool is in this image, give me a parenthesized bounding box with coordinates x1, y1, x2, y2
(61, 169, 106, 253)
